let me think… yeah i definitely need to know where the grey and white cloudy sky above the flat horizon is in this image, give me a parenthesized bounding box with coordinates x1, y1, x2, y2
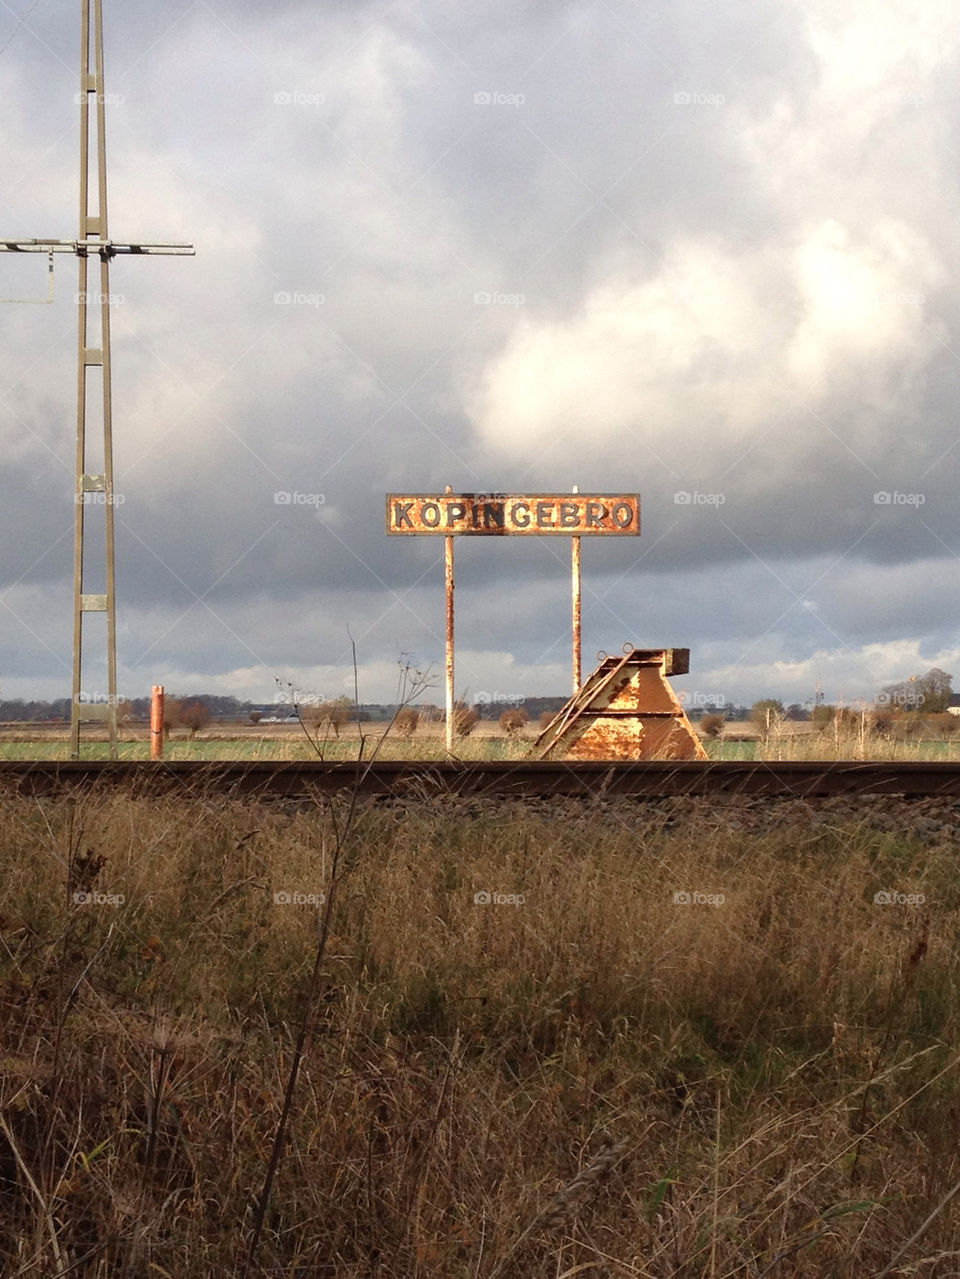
(0, 0, 960, 701)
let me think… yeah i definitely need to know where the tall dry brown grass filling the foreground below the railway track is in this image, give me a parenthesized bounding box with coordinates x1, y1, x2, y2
(0, 794, 960, 1279)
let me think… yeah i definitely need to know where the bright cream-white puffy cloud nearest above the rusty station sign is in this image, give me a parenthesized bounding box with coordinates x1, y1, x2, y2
(472, 219, 942, 473)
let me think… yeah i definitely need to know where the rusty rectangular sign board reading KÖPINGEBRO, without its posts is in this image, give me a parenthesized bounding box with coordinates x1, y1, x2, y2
(386, 492, 640, 537)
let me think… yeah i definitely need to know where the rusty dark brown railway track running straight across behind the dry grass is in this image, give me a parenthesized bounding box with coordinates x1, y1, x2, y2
(0, 760, 960, 799)
